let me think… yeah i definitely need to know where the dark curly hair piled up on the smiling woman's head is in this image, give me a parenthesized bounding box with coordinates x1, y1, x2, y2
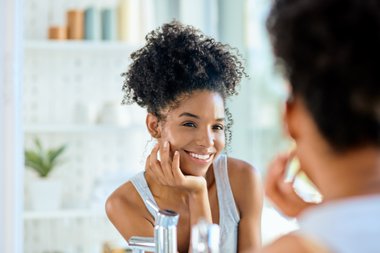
(122, 21, 246, 149)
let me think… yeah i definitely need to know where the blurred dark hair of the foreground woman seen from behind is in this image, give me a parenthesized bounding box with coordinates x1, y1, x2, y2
(267, 0, 380, 151)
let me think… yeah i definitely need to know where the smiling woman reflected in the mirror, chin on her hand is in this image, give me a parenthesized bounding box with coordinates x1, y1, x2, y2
(106, 22, 262, 252)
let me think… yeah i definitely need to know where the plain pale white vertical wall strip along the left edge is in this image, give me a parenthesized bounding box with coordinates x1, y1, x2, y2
(0, 0, 23, 253)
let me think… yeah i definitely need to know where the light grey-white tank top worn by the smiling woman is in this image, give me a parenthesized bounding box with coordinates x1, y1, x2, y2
(131, 155, 240, 253)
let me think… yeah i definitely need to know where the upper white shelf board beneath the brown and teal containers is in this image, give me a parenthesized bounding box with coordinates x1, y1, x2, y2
(24, 40, 139, 52)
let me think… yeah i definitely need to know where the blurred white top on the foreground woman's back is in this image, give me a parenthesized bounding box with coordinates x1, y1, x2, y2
(295, 195, 380, 253)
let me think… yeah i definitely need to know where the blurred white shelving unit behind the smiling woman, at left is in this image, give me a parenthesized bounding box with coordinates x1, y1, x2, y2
(23, 0, 149, 253)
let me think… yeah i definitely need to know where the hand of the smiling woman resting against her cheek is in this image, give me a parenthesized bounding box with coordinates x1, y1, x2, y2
(145, 141, 207, 194)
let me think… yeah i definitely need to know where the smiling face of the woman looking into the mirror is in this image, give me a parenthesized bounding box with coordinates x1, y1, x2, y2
(159, 91, 225, 176)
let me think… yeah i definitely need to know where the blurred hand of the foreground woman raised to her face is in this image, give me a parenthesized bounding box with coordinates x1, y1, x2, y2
(265, 153, 316, 217)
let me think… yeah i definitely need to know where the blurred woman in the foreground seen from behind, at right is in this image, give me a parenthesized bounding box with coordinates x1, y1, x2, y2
(260, 0, 380, 253)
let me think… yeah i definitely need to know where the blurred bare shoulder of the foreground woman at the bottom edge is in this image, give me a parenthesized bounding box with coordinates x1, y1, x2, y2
(259, 234, 329, 253)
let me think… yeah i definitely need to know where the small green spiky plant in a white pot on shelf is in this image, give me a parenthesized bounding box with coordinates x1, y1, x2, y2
(24, 138, 66, 211)
